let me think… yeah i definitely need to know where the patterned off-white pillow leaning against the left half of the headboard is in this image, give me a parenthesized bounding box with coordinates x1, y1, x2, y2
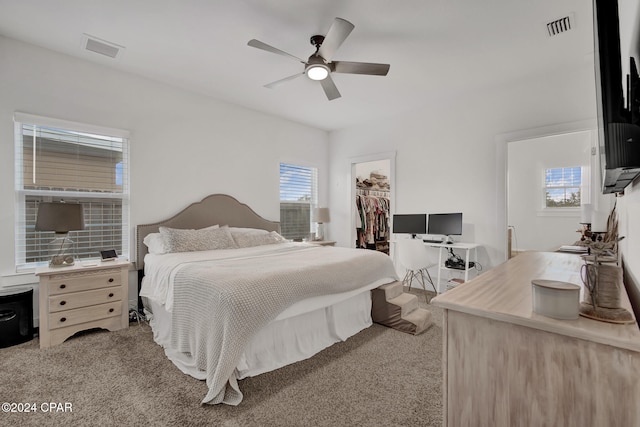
(160, 227, 238, 252)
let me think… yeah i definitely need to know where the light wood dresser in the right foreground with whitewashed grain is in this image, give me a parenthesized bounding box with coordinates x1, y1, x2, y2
(431, 252, 640, 427)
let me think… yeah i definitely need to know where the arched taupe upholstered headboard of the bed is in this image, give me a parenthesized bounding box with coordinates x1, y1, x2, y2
(136, 194, 280, 270)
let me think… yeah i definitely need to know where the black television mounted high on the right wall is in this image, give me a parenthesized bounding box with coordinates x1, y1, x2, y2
(593, 0, 640, 193)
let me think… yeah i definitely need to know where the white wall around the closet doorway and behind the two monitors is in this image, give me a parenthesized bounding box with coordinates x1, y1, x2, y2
(330, 63, 596, 268)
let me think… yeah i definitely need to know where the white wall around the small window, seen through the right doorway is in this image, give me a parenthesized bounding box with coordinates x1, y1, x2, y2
(507, 131, 600, 251)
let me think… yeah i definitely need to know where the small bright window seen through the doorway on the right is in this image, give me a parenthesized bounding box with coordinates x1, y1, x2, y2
(544, 166, 583, 208)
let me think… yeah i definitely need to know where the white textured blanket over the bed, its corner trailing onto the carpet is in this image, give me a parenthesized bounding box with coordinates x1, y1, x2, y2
(141, 243, 397, 405)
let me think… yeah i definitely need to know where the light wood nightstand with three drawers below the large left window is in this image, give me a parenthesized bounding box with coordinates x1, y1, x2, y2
(36, 260, 130, 348)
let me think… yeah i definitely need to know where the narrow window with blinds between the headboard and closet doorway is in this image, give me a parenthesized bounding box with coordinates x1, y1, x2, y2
(280, 163, 318, 239)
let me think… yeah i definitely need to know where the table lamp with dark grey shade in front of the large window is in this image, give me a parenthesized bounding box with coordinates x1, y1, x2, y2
(36, 202, 84, 267)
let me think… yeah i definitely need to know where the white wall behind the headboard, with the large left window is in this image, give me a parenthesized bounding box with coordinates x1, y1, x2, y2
(0, 37, 328, 308)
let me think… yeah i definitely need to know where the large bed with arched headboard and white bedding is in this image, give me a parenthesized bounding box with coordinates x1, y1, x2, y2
(136, 194, 398, 405)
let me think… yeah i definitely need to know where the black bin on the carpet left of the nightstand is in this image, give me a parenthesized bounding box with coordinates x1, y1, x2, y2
(0, 288, 33, 348)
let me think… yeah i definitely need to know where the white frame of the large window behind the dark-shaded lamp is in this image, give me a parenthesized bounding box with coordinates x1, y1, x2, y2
(14, 112, 130, 272)
